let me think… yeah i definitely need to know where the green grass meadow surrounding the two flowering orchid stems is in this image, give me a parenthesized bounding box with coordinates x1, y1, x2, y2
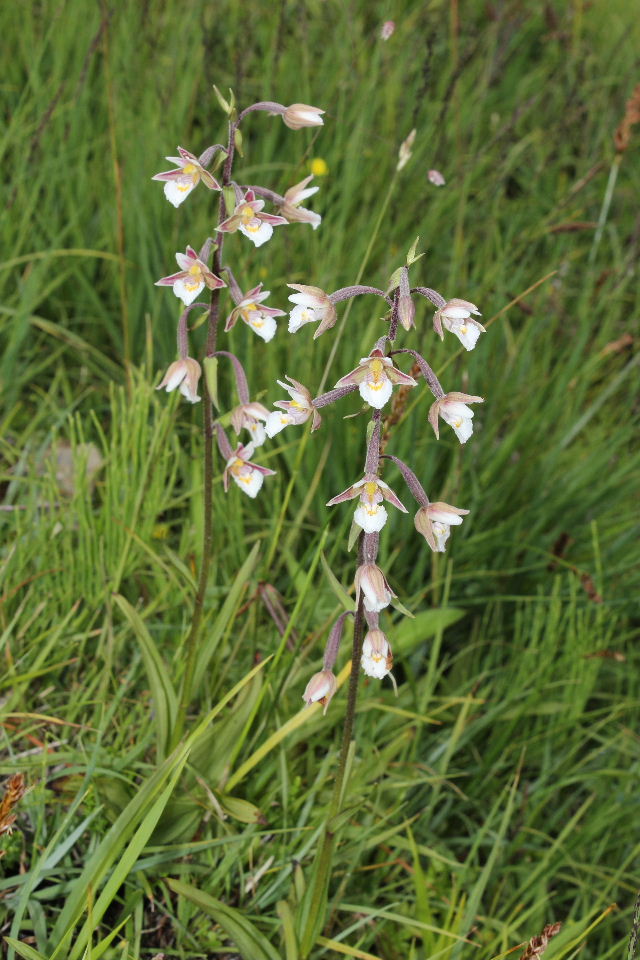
(0, 0, 640, 960)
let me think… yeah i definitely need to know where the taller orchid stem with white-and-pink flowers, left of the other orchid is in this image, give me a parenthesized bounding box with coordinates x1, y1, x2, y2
(153, 88, 324, 742)
